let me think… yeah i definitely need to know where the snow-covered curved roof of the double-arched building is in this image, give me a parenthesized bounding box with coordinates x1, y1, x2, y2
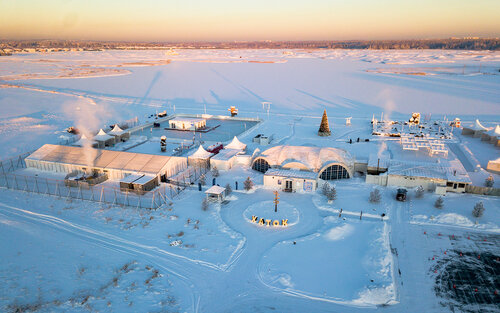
(254, 146, 354, 171)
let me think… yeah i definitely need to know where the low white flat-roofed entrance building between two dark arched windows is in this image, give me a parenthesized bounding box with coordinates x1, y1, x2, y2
(264, 168, 318, 192)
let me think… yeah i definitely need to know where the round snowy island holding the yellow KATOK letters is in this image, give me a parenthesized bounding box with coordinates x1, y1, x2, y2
(243, 201, 299, 228)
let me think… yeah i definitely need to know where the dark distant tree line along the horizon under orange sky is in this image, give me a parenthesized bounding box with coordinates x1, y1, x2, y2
(0, 38, 500, 50)
